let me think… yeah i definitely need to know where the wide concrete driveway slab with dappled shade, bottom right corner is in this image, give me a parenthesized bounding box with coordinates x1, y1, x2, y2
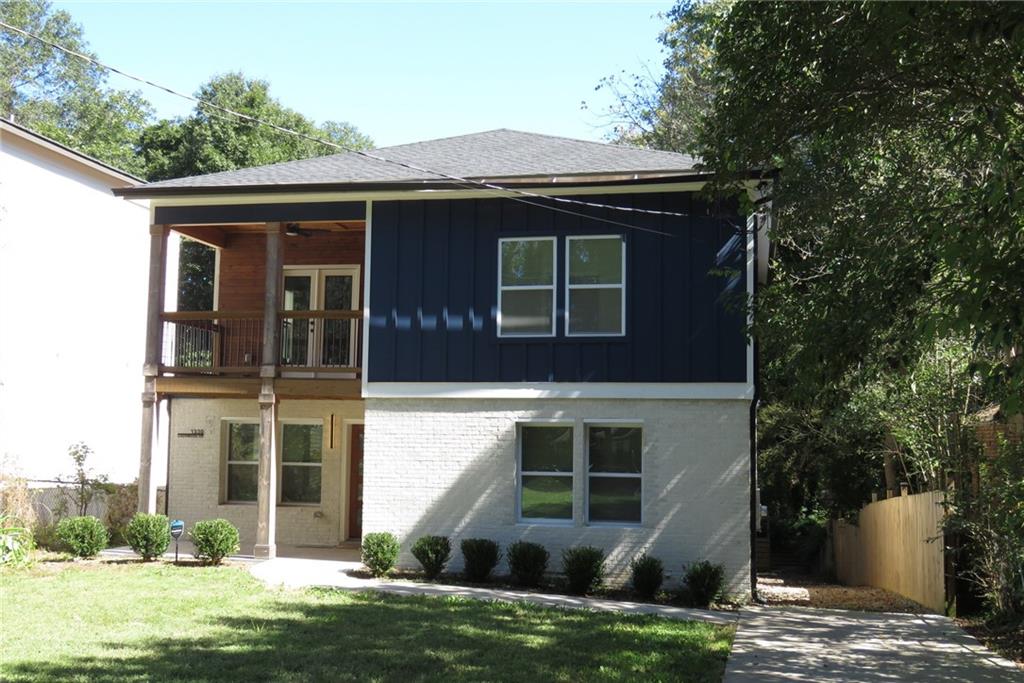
(725, 607, 1024, 683)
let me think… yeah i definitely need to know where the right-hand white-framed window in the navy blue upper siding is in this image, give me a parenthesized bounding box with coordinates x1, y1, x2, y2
(565, 234, 626, 337)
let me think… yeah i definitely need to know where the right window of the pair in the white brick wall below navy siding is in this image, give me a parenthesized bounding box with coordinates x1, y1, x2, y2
(587, 426, 643, 524)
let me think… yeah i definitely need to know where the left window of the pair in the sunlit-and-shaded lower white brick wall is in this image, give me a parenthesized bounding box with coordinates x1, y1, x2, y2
(519, 425, 572, 520)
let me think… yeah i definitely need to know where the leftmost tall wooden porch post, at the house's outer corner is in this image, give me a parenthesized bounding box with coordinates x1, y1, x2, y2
(138, 224, 167, 514)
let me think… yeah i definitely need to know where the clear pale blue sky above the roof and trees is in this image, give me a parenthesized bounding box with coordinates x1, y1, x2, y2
(54, 1, 672, 145)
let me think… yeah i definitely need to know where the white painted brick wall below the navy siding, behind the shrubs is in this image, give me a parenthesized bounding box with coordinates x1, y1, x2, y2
(364, 398, 750, 593)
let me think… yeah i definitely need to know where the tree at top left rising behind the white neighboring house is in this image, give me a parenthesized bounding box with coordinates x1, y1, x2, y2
(0, 0, 152, 175)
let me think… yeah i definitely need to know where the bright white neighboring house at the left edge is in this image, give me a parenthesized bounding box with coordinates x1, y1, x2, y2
(0, 119, 169, 481)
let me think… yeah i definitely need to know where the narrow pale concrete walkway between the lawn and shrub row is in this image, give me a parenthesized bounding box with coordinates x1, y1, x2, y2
(249, 557, 737, 625)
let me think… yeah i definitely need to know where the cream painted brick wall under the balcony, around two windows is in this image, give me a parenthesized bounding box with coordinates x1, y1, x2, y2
(168, 398, 362, 553)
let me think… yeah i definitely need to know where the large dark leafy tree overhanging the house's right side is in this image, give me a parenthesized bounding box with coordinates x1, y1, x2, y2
(698, 2, 1024, 407)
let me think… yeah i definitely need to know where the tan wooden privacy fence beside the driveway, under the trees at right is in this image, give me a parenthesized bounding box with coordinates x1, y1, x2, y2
(831, 492, 946, 613)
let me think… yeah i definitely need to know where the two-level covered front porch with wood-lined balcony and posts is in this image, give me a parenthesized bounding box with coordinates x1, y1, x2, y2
(139, 202, 368, 558)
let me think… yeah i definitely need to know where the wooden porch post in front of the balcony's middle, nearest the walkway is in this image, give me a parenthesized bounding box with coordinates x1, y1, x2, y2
(253, 223, 283, 558)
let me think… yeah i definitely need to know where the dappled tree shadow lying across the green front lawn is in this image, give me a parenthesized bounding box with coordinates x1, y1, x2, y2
(7, 590, 730, 681)
